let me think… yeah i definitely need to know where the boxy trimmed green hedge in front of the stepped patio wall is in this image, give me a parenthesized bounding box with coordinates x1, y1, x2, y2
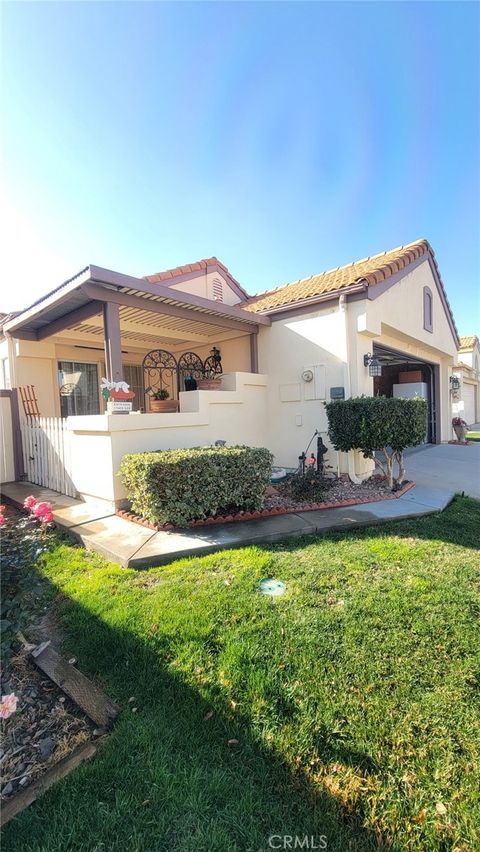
(120, 446, 273, 526)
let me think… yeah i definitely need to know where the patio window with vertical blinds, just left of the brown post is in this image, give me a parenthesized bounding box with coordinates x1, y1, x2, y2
(58, 361, 100, 417)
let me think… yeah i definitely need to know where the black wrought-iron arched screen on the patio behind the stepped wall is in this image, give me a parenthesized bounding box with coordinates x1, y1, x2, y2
(142, 346, 223, 399)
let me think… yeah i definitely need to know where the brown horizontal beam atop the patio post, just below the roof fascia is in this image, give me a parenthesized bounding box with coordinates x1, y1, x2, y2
(82, 284, 258, 334)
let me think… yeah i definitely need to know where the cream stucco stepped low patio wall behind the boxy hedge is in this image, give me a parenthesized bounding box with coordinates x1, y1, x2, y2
(67, 373, 267, 506)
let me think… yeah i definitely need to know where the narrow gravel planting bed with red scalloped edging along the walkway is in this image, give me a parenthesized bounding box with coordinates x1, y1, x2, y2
(117, 474, 415, 532)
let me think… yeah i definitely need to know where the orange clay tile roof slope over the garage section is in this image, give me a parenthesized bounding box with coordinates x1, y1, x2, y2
(242, 240, 433, 312)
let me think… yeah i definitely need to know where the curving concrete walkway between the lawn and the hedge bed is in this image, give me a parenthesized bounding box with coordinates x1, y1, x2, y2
(2, 476, 456, 568)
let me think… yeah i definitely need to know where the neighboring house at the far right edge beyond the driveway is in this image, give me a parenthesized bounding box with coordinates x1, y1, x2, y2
(452, 334, 480, 426)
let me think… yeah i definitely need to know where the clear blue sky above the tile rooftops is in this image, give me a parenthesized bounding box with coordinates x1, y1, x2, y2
(0, 0, 480, 334)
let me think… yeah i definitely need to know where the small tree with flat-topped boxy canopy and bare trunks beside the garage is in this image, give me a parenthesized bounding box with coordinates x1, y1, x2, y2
(325, 396, 428, 490)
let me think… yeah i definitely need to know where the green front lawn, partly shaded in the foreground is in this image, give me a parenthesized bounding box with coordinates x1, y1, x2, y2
(3, 498, 480, 852)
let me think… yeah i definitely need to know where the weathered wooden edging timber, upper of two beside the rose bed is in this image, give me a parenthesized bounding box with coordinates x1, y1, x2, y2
(32, 644, 120, 728)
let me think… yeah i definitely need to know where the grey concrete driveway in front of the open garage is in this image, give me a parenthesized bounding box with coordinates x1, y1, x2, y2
(405, 442, 480, 500)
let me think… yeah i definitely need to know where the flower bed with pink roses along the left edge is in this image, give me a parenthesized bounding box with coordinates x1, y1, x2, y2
(0, 497, 95, 806)
